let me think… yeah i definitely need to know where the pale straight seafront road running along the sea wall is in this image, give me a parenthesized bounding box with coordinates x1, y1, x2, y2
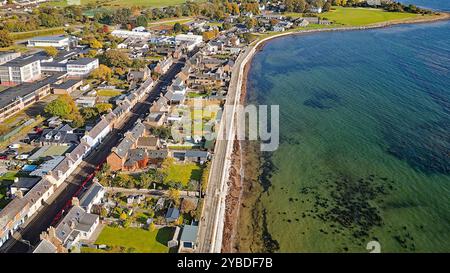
(197, 43, 255, 253)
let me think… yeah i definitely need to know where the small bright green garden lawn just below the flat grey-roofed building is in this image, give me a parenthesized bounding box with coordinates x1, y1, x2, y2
(163, 159, 202, 186)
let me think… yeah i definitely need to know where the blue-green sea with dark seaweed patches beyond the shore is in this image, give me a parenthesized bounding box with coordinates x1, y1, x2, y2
(248, 22, 450, 252)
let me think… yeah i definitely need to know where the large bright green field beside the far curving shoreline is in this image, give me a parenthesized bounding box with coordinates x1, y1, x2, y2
(321, 7, 421, 26)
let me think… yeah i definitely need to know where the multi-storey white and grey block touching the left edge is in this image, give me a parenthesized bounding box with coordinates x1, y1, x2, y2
(0, 55, 41, 86)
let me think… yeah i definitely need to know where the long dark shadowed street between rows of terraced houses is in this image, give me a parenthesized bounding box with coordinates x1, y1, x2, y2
(0, 56, 185, 253)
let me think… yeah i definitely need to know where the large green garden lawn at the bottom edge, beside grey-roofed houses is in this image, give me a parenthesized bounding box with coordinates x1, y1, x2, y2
(92, 226, 173, 253)
